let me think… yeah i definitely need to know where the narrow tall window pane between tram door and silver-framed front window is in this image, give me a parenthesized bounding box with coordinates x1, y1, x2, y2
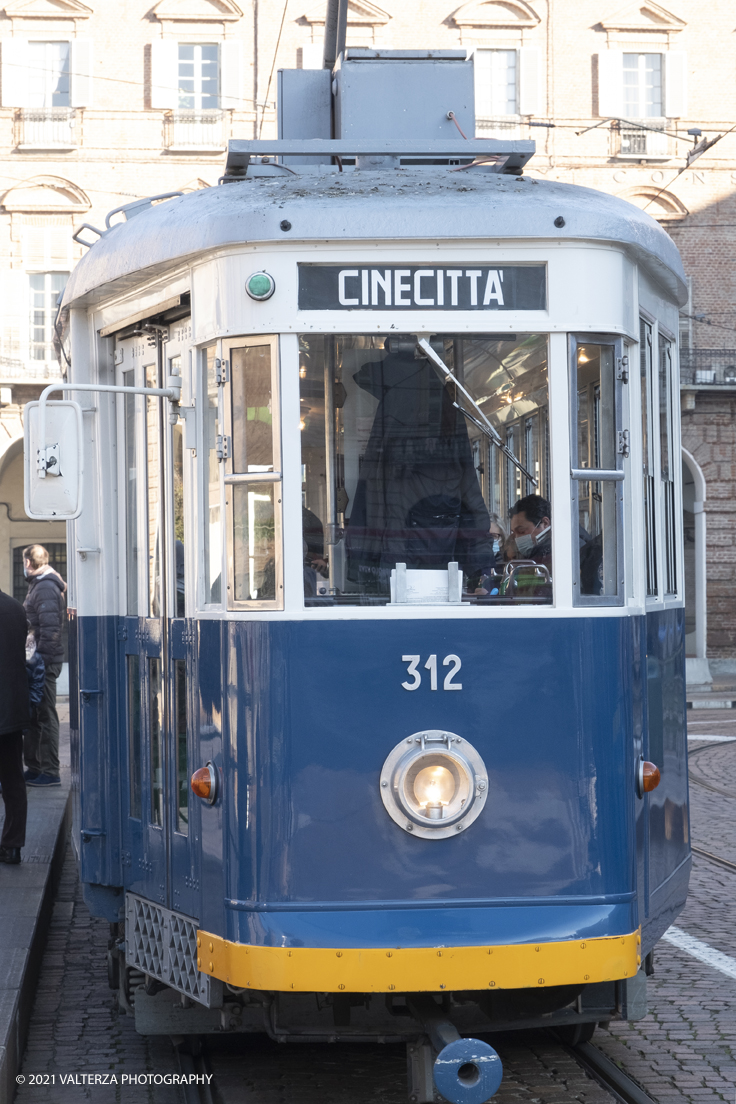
(202, 346, 222, 605)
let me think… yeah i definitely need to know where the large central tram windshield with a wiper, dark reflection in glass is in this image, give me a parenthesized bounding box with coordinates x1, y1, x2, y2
(299, 333, 552, 606)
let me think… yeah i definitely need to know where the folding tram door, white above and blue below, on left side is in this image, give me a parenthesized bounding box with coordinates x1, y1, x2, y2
(115, 319, 200, 917)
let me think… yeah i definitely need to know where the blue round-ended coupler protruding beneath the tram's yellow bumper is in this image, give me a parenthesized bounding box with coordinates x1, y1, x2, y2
(406, 994, 503, 1104)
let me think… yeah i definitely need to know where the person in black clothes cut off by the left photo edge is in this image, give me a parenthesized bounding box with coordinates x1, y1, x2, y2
(0, 591, 30, 864)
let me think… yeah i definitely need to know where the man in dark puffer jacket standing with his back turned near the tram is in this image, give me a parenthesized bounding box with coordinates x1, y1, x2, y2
(23, 544, 66, 787)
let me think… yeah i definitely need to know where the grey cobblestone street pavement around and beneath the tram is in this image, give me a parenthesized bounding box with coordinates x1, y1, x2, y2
(17, 710, 736, 1104)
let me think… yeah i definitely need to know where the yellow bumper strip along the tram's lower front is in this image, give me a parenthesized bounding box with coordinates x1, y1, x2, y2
(196, 931, 641, 992)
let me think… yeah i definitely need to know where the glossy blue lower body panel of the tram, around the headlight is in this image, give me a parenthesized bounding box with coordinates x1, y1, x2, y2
(71, 609, 689, 953)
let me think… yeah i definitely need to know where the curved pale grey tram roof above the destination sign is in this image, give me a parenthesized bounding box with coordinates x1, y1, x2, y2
(63, 172, 687, 307)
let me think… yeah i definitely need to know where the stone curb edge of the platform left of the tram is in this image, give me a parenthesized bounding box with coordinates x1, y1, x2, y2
(0, 789, 72, 1104)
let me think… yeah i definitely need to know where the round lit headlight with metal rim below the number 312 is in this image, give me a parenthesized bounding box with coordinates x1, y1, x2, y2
(381, 729, 488, 839)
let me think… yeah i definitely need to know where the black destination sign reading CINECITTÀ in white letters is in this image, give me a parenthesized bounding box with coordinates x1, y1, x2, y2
(299, 265, 547, 310)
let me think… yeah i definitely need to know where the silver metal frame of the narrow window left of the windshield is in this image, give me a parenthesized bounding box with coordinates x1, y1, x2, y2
(221, 333, 284, 612)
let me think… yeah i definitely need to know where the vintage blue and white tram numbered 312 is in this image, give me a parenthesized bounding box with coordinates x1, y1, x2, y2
(28, 43, 690, 1102)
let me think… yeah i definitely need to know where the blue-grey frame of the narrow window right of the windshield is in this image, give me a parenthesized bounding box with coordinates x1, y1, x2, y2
(569, 332, 630, 607)
